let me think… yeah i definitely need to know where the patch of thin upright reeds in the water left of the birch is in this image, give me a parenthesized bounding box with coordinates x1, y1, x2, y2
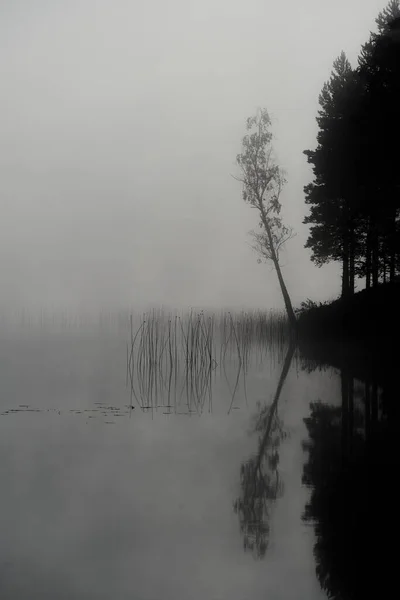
(126, 310, 289, 414)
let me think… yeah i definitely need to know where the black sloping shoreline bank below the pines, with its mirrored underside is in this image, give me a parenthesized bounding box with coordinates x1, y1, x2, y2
(298, 282, 400, 392)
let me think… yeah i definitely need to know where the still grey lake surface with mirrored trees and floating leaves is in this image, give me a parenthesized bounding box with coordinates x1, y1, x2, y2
(0, 316, 396, 600)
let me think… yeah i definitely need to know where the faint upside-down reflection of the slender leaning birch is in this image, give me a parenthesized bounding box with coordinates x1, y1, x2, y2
(234, 342, 295, 558)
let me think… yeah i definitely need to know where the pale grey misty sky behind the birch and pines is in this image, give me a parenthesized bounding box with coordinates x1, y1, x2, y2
(0, 0, 385, 311)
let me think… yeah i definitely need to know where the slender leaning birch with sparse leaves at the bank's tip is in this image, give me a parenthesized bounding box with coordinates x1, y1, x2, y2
(235, 109, 296, 328)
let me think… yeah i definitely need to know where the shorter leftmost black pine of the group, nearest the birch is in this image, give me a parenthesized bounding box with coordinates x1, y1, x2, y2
(304, 52, 360, 296)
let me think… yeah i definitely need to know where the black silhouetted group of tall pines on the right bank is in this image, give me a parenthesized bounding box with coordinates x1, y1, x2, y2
(304, 0, 400, 298)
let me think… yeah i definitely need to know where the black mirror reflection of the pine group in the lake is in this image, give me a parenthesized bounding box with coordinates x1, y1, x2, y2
(303, 344, 400, 600)
